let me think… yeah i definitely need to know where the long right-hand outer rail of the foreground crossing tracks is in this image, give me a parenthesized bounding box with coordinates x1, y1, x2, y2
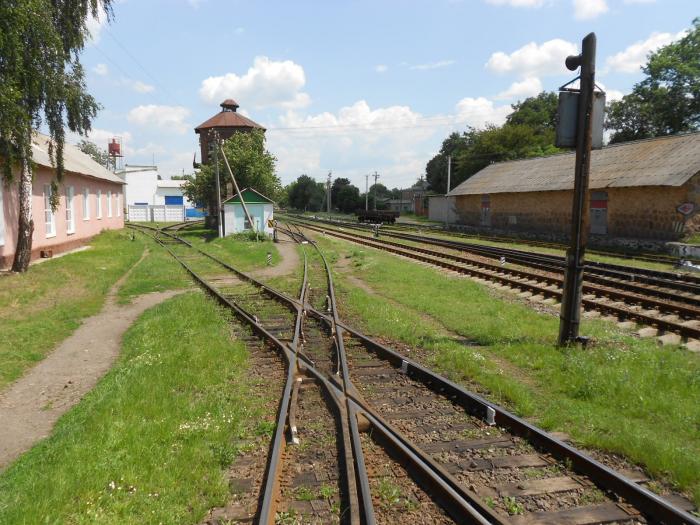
(129, 223, 700, 525)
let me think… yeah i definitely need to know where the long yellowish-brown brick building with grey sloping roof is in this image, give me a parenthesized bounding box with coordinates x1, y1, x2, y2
(449, 133, 700, 240)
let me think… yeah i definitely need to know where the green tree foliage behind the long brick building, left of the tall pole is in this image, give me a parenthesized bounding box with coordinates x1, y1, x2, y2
(425, 92, 559, 193)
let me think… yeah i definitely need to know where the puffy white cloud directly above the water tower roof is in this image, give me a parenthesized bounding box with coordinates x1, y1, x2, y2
(199, 56, 311, 109)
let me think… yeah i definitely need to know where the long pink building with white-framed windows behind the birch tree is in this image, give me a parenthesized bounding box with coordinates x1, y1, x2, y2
(0, 133, 124, 268)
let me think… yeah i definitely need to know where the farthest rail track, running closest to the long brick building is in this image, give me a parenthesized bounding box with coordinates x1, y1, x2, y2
(288, 214, 697, 265)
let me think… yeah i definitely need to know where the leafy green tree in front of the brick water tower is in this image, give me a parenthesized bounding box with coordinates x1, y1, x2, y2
(182, 129, 282, 227)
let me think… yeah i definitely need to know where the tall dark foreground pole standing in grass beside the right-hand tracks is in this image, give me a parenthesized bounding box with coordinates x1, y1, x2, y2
(559, 33, 596, 345)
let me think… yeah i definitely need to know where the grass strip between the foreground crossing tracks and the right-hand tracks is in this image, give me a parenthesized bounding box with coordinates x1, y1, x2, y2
(320, 234, 700, 503)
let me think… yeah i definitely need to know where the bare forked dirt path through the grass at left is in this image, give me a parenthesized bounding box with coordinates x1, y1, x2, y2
(0, 249, 183, 470)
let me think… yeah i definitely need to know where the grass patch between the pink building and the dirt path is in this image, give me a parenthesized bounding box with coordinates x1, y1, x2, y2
(0, 231, 144, 389)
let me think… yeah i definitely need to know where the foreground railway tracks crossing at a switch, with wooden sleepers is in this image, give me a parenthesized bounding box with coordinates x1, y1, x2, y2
(124, 222, 700, 525)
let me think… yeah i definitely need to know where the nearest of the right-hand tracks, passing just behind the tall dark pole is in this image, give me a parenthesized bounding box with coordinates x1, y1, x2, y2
(284, 218, 700, 341)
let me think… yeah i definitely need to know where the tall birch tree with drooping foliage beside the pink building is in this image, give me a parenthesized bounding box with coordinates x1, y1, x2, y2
(0, 0, 112, 272)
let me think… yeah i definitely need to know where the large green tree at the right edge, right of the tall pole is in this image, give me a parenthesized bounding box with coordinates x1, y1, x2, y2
(605, 18, 700, 143)
